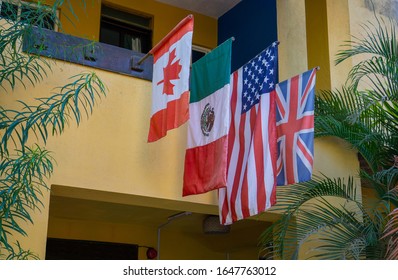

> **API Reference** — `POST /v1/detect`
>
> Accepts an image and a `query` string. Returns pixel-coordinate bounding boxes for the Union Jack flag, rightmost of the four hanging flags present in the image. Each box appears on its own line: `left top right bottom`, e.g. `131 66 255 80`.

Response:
275 68 316 186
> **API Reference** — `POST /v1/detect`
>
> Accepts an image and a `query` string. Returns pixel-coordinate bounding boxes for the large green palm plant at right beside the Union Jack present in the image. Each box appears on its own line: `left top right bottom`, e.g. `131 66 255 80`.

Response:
261 16 398 259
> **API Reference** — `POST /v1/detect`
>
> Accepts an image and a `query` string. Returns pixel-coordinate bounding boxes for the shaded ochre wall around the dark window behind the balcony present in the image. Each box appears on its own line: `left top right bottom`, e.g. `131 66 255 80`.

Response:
57 0 217 48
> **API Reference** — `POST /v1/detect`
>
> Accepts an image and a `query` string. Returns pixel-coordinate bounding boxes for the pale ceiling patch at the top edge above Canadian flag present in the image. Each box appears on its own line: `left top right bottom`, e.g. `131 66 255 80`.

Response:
156 0 241 18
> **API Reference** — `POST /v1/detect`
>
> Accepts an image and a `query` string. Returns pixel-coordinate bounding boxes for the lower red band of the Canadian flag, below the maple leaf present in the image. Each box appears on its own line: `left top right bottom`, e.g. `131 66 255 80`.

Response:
148 91 189 142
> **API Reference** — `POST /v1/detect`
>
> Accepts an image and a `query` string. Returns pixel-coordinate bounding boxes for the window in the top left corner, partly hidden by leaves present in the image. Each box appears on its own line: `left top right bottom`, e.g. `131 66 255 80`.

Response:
0 0 58 30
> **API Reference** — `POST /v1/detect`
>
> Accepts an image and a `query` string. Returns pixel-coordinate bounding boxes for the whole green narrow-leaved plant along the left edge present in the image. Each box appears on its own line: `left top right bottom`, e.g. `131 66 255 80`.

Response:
0 0 106 259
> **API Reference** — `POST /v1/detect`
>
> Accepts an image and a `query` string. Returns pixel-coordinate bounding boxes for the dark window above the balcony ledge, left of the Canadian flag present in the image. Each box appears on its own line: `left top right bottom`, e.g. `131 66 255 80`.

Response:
100 5 152 53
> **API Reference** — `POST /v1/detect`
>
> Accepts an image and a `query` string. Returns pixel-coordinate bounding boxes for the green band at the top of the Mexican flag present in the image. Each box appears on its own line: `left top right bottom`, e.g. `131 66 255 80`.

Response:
189 39 232 103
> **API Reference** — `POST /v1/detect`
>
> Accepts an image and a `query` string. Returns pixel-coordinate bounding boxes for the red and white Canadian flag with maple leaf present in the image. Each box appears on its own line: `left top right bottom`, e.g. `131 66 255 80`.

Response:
148 15 193 142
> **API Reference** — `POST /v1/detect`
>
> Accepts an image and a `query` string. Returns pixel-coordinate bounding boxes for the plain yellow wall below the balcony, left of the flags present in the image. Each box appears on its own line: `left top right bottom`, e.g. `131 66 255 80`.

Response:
41 65 214 206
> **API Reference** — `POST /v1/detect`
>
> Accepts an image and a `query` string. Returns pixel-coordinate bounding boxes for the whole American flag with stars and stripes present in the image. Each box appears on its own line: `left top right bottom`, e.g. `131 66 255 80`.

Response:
219 43 278 224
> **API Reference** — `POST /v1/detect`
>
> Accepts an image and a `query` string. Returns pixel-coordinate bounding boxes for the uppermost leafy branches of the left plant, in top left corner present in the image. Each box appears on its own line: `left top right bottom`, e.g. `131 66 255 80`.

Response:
0 0 86 90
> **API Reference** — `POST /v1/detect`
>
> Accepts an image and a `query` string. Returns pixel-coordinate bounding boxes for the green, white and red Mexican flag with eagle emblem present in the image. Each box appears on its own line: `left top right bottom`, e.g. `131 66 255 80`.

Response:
183 39 232 196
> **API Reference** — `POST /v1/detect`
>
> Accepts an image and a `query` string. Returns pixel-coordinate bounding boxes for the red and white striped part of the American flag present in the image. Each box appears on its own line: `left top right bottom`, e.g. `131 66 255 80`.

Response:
219 68 277 224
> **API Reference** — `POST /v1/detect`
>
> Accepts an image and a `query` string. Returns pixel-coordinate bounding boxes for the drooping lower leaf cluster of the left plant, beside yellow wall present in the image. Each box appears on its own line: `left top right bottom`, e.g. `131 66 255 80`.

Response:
0 146 54 250
